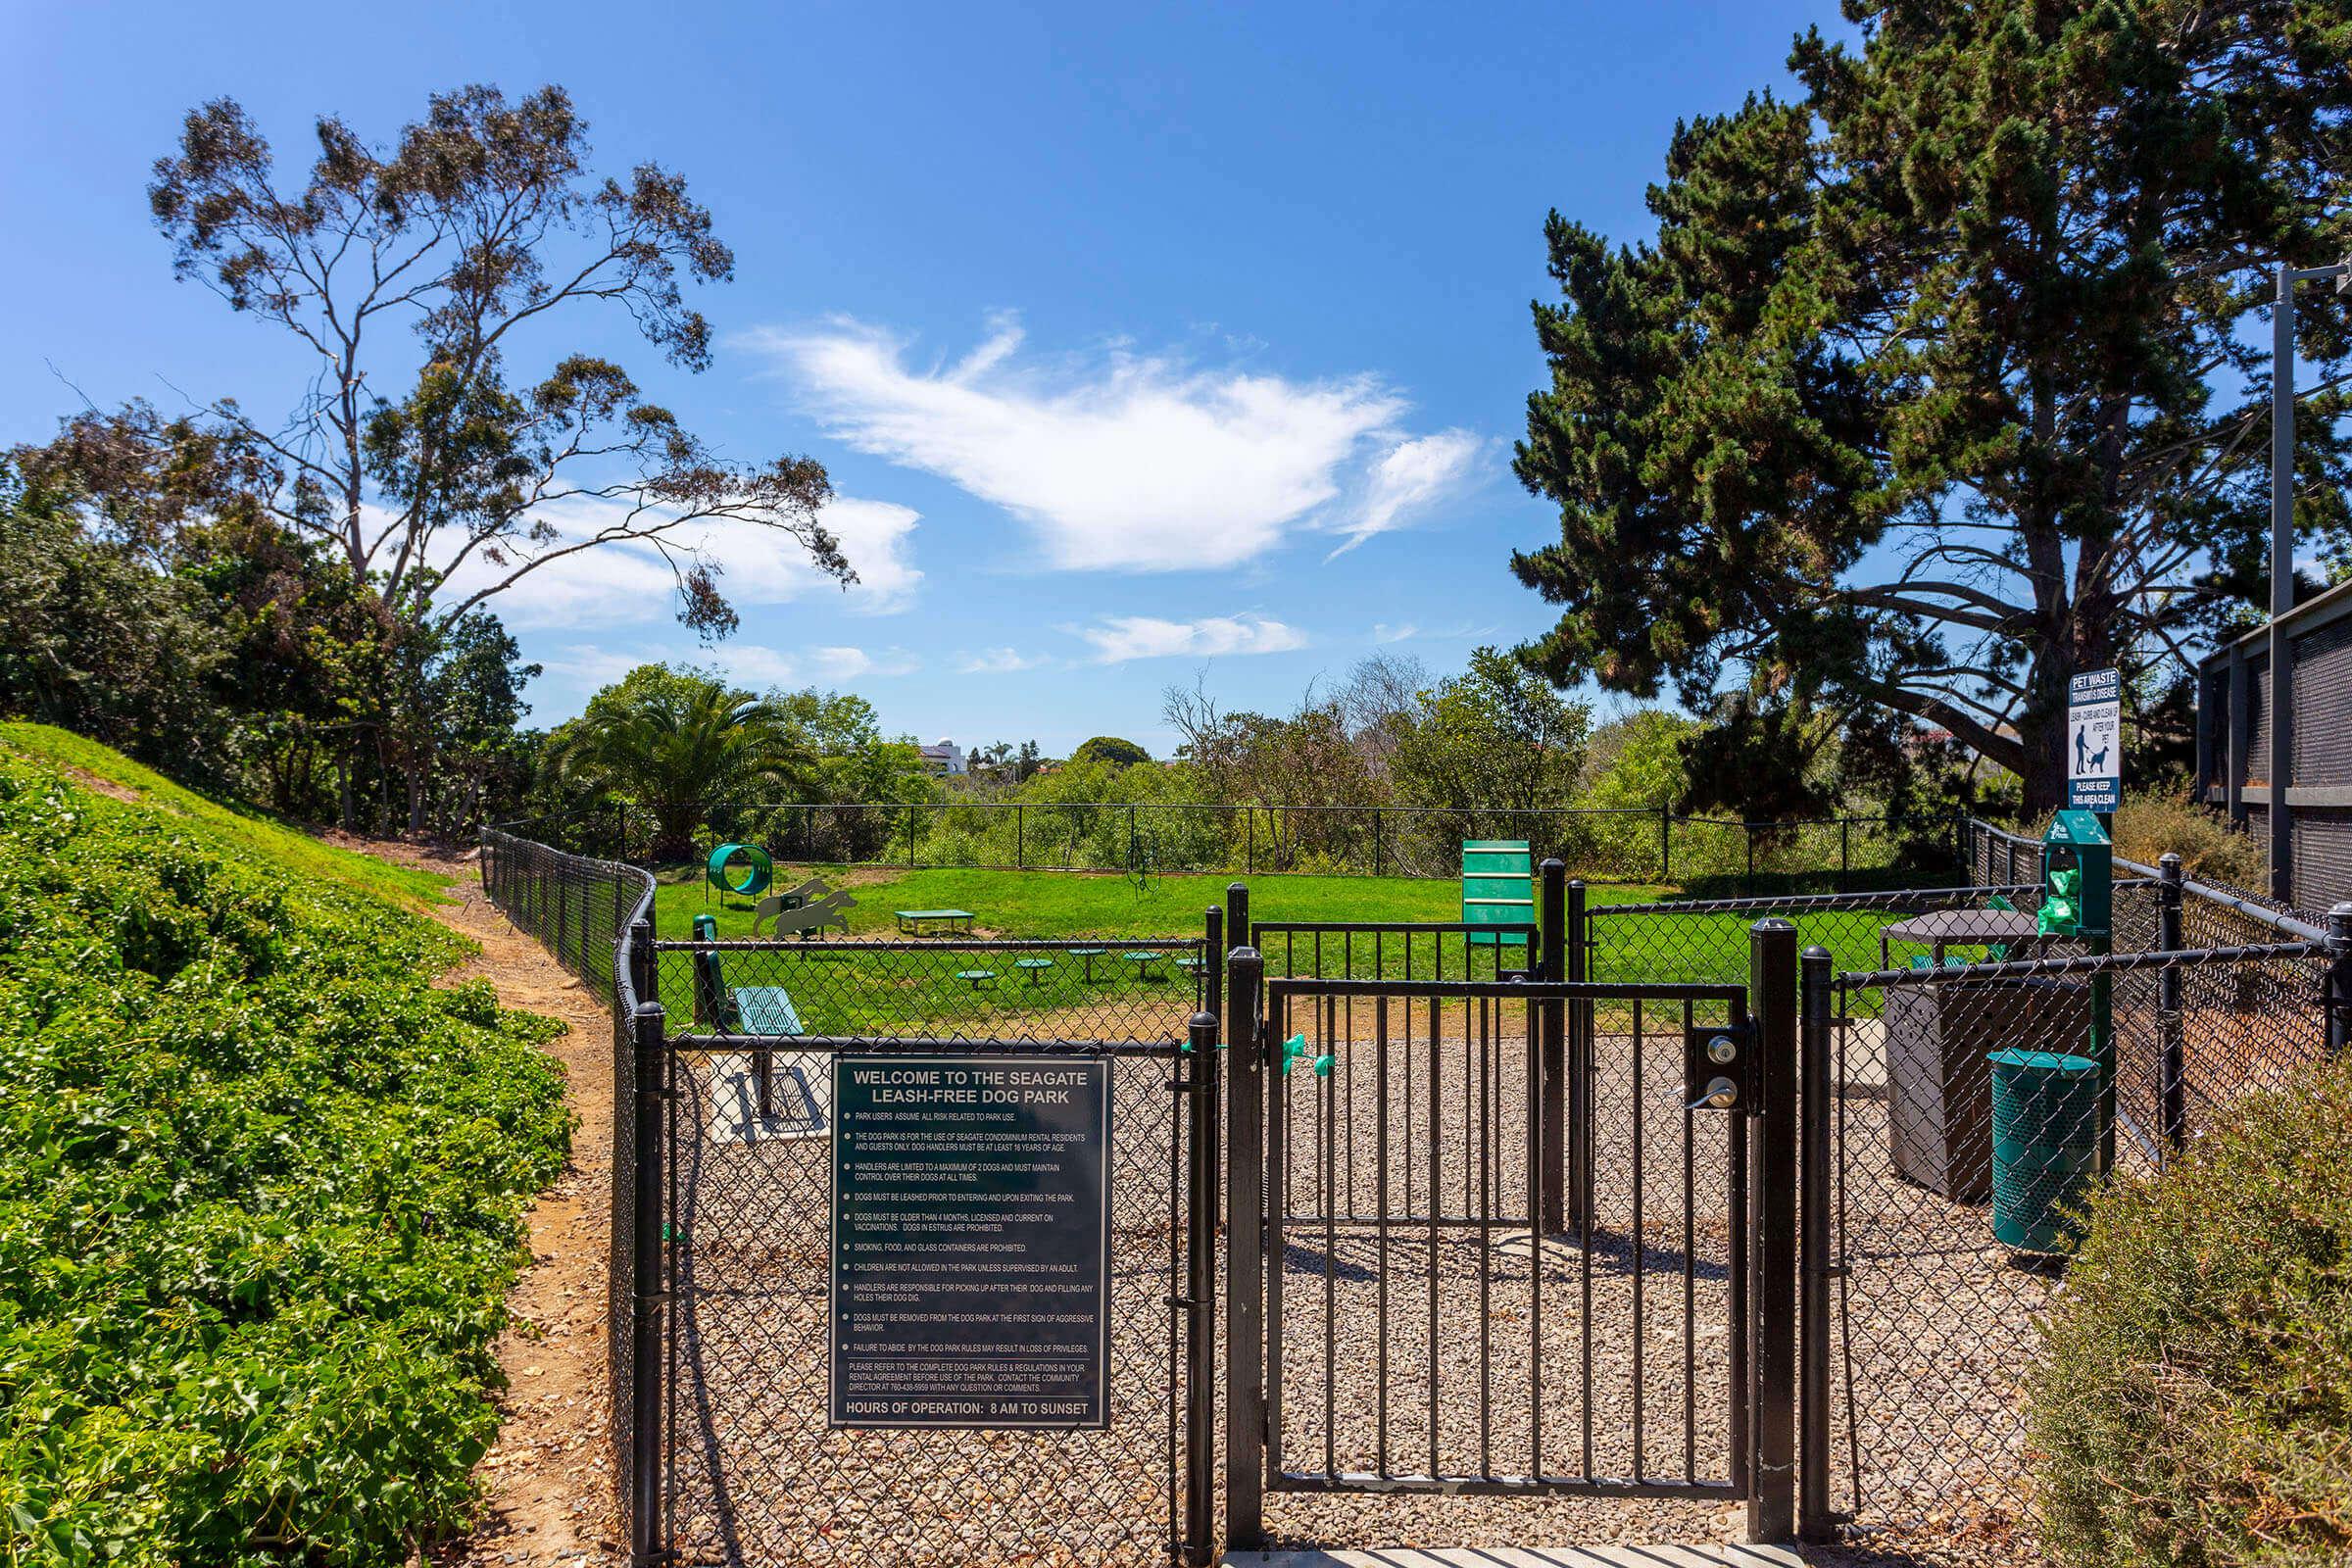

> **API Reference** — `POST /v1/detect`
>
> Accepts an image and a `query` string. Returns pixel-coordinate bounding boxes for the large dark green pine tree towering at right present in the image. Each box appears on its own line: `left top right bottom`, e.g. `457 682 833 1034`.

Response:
1512 0 2352 811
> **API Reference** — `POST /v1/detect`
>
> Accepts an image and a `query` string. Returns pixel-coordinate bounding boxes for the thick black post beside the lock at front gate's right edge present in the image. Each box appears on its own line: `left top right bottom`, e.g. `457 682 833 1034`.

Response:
1745 919 1797 1543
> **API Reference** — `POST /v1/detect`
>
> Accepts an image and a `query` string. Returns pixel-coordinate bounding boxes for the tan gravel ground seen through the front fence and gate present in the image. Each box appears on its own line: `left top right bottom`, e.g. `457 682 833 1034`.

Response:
654 1004 2051 1563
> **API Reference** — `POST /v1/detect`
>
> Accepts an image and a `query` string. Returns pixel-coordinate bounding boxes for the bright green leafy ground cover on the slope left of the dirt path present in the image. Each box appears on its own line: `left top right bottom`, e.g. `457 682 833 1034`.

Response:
0 753 569 1566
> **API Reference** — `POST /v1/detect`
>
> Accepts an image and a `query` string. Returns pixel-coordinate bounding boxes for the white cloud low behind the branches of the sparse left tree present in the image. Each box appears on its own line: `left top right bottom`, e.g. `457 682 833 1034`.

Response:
445 496 922 632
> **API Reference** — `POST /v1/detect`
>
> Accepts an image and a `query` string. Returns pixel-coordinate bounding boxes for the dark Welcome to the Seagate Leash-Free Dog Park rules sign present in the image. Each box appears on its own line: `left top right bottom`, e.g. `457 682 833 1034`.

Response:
825 1055 1110 1427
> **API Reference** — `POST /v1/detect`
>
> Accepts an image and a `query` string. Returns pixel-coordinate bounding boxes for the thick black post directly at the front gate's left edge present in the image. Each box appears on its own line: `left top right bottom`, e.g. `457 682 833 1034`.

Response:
1225 945 1265 1551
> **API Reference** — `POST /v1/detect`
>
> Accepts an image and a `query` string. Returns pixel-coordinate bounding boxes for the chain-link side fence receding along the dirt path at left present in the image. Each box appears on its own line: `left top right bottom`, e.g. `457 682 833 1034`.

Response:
480 827 654 1551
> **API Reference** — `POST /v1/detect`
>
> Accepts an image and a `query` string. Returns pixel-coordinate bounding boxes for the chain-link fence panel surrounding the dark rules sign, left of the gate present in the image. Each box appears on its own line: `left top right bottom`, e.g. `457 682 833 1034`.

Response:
659 938 1204 1563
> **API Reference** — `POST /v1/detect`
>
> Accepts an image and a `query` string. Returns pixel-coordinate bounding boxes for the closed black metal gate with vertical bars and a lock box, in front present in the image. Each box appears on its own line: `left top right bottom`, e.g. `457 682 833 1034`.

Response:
1225 921 1797 1546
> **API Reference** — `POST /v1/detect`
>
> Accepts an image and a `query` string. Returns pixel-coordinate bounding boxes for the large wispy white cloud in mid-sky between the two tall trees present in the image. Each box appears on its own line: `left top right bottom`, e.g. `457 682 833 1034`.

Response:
741 315 1480 571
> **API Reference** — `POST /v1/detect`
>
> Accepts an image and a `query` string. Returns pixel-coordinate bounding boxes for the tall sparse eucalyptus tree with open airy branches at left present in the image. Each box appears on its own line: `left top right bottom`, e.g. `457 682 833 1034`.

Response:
133 87 854 813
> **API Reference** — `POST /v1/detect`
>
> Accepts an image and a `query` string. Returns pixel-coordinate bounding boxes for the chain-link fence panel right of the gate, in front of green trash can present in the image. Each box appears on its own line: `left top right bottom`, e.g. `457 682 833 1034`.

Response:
1835 930 2324 1554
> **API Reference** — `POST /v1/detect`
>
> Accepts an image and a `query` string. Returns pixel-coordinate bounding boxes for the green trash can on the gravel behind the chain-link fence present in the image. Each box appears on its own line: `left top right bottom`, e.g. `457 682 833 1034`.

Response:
1985 1049 2098 1253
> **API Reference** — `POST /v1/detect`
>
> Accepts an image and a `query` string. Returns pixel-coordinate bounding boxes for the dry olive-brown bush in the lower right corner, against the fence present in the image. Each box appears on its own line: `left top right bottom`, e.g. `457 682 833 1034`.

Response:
2028 1062 2352 1568
